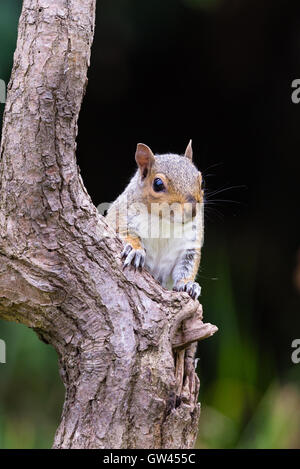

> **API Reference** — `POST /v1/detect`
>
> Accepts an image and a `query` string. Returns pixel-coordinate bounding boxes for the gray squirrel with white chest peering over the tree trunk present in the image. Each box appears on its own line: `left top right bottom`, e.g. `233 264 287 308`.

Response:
106 140 204 300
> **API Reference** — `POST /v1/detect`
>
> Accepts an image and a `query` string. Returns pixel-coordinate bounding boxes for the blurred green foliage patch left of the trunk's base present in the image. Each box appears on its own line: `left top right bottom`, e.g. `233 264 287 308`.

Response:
0 321 64 448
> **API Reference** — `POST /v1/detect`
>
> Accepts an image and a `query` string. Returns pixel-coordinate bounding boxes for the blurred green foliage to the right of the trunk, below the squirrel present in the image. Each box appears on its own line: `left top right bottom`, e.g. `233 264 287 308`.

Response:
197 234 300 448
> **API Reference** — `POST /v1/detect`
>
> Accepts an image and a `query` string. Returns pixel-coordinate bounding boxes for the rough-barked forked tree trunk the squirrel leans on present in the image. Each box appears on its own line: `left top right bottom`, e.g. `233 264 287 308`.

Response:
0 0 216 448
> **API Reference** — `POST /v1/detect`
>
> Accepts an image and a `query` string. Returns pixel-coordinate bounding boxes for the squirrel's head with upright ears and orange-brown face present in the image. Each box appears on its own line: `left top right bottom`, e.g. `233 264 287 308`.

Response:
135 140 203 219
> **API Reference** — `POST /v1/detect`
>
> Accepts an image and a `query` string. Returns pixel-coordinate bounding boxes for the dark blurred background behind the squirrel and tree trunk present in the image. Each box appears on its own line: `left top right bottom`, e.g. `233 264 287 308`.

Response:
0 0 300 447
